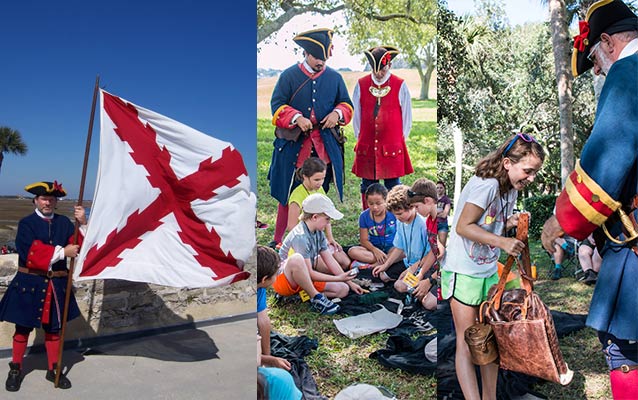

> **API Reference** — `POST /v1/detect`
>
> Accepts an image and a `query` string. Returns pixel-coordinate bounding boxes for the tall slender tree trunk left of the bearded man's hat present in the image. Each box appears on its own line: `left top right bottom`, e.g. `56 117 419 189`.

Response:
549 0 574 185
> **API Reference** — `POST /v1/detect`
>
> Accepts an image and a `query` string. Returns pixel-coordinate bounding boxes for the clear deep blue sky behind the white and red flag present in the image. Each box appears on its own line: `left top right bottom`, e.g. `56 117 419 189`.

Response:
0 0 256 199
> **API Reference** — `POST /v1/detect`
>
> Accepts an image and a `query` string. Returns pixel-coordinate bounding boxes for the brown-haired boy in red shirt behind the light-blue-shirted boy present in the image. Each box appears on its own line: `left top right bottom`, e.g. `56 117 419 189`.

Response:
408 178 444 310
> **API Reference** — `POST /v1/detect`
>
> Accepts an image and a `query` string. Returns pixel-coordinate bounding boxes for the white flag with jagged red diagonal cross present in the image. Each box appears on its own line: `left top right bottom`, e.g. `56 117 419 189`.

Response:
74 90 256 287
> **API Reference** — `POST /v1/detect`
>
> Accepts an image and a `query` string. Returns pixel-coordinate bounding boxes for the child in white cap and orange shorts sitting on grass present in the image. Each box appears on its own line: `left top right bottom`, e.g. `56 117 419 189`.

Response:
273 193 363 314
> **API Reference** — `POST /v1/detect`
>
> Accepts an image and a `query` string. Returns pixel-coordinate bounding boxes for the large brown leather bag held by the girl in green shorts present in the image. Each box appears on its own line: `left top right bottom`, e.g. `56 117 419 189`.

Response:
479 214 574 385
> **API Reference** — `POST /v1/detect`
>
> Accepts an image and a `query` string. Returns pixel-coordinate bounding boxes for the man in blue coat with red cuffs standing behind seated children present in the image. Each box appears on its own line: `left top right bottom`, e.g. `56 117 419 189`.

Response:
268 29 352 245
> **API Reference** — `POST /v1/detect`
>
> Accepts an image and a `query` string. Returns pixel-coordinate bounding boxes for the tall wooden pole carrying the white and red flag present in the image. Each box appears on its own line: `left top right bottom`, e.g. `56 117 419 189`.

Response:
54 75 100 388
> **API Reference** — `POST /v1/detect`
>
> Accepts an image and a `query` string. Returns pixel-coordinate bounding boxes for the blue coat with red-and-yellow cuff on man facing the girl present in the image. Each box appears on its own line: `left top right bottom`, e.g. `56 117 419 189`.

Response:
556 54 638 340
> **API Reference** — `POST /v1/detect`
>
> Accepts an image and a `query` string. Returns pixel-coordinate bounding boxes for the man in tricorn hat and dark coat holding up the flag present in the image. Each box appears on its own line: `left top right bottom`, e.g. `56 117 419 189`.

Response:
0 181 86 392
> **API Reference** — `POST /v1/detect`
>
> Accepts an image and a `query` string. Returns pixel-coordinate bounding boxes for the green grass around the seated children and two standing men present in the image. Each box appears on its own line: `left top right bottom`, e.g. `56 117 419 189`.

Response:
257 101 436 399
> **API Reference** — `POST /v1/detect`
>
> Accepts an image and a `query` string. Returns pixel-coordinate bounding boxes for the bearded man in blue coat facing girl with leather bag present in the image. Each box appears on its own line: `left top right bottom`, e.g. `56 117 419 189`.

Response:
542 0 638 399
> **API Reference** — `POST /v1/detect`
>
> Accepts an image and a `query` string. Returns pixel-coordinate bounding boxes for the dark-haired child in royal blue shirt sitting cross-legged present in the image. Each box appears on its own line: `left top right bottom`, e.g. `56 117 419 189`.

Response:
348 183 397 265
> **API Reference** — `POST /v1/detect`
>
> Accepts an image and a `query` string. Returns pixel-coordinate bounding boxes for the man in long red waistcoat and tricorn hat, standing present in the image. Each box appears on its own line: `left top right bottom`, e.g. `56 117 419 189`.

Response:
352 46 414 210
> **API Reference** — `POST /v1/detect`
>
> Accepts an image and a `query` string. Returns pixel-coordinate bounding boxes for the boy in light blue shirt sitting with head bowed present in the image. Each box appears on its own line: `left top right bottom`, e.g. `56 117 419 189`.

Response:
372 185 434 292
